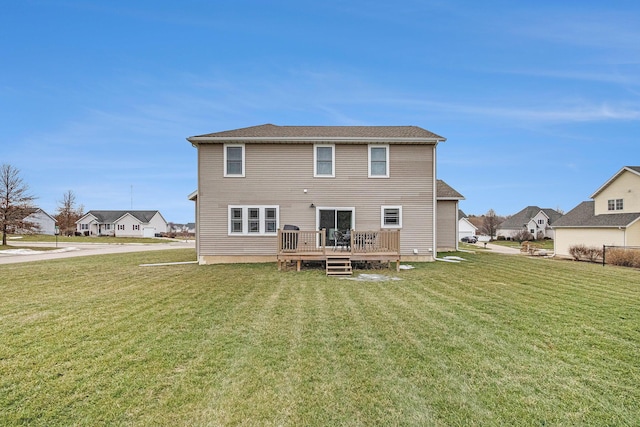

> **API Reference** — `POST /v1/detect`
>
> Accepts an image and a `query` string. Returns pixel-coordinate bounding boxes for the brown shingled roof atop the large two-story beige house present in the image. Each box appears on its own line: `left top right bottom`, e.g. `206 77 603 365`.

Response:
187 124 446 144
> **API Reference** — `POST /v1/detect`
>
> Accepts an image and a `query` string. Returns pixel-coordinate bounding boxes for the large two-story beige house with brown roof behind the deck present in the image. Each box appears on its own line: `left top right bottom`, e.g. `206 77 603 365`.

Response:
187 124 452 264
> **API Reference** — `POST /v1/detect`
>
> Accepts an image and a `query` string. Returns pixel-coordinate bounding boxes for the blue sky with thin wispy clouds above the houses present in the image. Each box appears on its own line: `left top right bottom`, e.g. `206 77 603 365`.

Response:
0 0 640 223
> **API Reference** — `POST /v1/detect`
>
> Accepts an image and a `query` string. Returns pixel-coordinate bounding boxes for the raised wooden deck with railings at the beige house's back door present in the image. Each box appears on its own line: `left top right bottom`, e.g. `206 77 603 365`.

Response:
278 230 400 271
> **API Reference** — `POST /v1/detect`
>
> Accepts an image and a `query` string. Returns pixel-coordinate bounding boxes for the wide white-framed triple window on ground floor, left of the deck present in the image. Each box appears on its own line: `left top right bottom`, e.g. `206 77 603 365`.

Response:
229 206 279 236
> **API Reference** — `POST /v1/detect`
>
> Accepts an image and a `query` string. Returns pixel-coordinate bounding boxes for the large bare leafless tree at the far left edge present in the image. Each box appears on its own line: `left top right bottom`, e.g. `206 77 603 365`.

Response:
0 164 37 246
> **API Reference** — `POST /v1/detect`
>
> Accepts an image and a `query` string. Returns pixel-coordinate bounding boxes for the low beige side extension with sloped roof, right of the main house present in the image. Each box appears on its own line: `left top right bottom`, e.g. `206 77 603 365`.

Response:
436 179 464 252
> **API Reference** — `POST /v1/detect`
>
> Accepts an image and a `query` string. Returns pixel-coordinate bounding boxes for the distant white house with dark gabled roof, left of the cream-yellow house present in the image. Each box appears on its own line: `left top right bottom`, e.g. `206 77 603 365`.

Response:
496 206 562 239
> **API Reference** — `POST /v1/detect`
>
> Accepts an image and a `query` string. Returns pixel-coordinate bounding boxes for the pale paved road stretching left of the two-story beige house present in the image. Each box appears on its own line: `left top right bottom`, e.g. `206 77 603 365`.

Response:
0 240 195 264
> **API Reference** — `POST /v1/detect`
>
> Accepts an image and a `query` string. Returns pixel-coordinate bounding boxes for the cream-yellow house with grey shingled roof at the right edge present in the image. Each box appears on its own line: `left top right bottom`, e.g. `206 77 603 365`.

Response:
553 166 640 257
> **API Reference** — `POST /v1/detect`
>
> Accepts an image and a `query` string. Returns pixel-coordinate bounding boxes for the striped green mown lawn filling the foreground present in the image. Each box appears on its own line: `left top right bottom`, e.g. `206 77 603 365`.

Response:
0 250 640 426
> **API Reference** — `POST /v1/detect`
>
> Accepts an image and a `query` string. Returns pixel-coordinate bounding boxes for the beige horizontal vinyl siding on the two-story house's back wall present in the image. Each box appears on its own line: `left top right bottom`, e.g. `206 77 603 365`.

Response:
197 142 435 257
